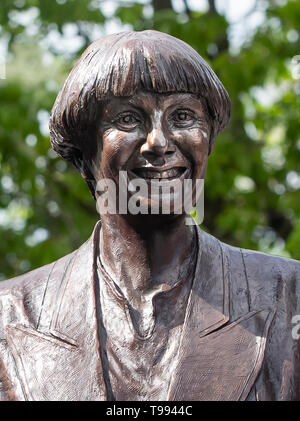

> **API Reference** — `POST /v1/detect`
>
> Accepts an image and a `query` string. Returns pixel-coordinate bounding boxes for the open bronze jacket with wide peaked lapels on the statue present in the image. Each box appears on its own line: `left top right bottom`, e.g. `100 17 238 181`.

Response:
0 222 300 401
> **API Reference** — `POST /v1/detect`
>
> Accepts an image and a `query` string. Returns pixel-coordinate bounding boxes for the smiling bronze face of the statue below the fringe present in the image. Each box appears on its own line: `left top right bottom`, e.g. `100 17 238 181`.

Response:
95 92 210 213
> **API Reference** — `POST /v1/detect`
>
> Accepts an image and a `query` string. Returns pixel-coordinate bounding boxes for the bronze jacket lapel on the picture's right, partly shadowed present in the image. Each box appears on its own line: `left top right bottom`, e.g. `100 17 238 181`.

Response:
169 226 273 401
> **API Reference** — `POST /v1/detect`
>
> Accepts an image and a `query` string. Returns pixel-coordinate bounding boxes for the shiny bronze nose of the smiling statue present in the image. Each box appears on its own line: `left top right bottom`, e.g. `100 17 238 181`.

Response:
141 127 174 165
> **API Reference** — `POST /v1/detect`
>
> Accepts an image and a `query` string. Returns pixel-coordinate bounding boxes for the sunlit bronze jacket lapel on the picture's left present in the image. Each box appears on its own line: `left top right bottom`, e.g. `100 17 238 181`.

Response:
7 221 106 400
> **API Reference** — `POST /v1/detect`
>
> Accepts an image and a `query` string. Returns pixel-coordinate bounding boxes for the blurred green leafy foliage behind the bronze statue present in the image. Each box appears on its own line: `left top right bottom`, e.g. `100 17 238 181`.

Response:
0 0 300 279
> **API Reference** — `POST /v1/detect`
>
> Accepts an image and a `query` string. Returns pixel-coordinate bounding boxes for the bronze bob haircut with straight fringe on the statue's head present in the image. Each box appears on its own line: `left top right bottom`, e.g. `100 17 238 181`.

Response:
50 30 230 194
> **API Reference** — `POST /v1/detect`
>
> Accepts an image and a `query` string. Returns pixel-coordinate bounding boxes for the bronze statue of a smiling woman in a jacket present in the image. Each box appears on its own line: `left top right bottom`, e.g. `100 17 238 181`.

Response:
0 31 300 401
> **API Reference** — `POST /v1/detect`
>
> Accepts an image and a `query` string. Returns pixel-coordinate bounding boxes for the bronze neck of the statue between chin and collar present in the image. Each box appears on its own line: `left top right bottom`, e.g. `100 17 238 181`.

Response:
100 215 194 302
